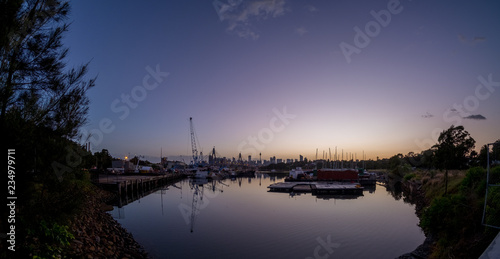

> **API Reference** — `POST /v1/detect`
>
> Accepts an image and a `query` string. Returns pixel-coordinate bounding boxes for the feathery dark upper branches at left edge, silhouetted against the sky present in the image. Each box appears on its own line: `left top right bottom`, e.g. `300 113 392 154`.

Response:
0 0 95 138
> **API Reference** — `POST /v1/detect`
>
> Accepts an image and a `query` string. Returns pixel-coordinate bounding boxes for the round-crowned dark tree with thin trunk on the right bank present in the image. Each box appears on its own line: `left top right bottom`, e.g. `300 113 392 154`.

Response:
434 125 476 194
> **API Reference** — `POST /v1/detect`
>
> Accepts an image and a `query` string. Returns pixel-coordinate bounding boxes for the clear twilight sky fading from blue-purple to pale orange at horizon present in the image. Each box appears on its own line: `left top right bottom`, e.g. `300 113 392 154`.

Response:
64 0 500 162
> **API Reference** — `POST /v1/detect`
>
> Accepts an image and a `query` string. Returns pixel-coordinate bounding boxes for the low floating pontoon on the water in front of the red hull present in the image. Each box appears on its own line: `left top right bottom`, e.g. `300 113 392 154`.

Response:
267 182 364 195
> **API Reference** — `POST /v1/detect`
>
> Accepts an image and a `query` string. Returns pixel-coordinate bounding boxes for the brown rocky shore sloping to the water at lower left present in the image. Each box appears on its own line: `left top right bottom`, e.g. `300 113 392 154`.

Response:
63 188 148 259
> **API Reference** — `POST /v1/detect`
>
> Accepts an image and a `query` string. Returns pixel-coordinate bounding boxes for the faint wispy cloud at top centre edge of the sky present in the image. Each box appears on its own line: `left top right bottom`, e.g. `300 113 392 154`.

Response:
214 0 286 40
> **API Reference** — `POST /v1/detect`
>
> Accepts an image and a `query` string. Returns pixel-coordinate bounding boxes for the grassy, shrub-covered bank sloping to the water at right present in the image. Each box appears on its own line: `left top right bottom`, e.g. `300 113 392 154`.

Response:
392 168 500 259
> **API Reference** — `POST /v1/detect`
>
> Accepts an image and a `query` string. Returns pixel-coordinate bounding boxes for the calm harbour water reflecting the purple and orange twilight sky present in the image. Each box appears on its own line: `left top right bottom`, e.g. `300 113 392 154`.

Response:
111 175 425 258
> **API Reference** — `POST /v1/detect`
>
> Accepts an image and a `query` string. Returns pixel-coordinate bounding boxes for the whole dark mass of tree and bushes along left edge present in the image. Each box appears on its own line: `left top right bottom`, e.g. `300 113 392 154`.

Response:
0 0 95 258
